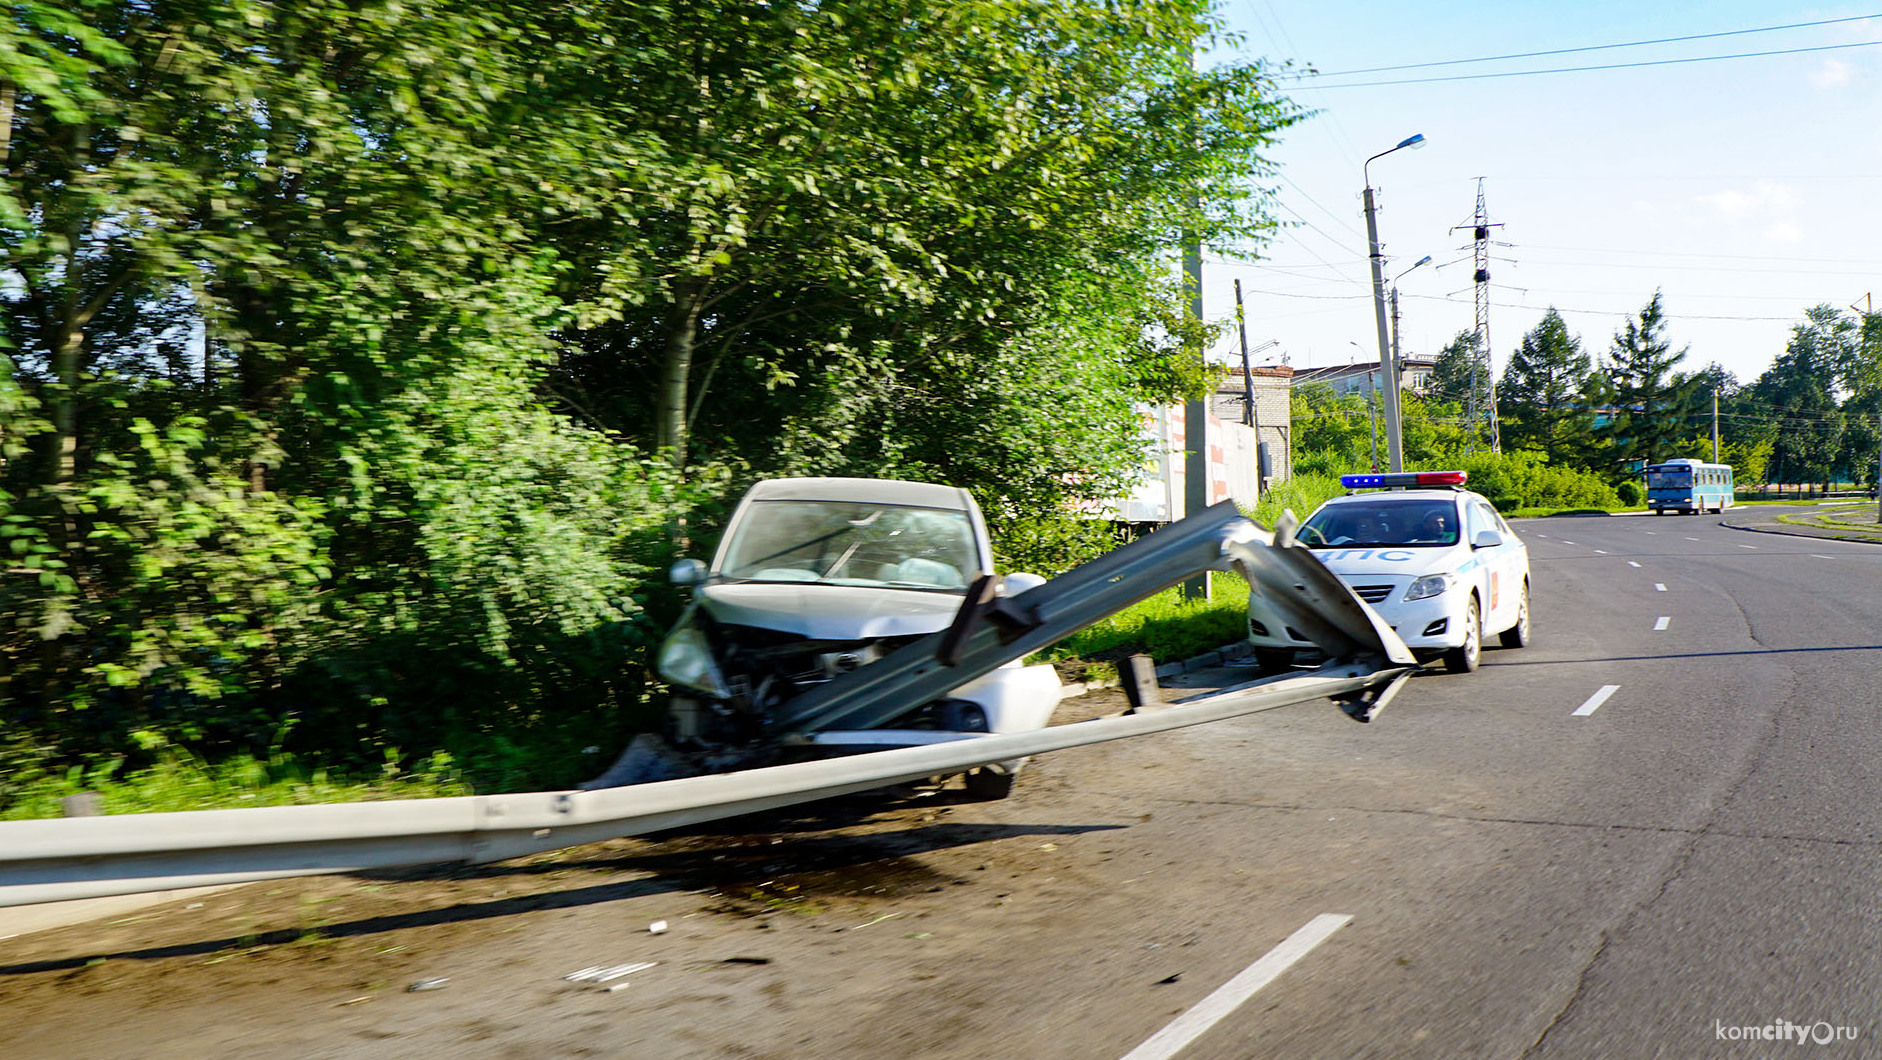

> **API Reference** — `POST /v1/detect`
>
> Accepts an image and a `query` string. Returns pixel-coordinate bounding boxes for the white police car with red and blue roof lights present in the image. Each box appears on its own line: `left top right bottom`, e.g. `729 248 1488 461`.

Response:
1248 471 1530 674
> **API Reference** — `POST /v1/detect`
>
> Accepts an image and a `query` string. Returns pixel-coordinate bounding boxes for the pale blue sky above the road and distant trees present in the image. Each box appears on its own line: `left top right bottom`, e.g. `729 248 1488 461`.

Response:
1204 0 1882 382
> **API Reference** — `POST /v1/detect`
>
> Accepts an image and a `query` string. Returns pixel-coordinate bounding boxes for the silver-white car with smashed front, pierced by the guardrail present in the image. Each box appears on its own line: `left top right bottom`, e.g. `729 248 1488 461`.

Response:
659 478 1060 798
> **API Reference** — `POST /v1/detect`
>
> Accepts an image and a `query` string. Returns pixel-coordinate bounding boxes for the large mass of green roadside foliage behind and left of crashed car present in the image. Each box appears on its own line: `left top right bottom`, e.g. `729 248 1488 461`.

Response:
0 0 1297 783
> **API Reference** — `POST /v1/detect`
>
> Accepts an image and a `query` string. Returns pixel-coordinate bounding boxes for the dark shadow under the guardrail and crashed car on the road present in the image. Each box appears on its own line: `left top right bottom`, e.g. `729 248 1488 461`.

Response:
0 808 1124 979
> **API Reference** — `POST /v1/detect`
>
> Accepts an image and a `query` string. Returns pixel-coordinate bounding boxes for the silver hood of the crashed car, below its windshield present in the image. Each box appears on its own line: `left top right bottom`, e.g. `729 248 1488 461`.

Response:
698 582 962 640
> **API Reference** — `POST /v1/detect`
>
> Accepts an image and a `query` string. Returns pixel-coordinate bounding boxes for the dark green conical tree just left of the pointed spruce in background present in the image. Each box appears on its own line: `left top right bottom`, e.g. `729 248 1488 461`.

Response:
1496 307 1594 463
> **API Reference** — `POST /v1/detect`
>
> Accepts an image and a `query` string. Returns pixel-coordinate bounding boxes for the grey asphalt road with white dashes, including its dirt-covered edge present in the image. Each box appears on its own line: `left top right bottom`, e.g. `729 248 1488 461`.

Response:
0 516 1882 1060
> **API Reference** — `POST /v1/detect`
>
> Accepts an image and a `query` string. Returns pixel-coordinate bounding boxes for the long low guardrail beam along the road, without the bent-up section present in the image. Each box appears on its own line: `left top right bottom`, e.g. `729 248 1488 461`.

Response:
0 663 1412 906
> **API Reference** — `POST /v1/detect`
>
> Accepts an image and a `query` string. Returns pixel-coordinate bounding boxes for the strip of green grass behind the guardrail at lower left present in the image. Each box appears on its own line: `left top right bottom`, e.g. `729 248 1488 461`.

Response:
0 751 471 821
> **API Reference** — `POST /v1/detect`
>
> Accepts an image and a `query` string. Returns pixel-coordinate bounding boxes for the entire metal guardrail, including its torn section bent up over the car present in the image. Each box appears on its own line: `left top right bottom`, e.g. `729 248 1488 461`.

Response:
0 505 1417 906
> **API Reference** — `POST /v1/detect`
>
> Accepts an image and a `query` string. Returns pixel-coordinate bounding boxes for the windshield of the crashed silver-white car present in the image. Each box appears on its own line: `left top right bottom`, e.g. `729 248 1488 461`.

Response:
717 501 981 593
